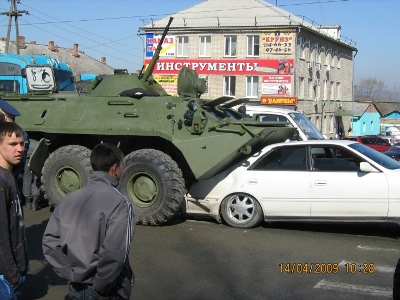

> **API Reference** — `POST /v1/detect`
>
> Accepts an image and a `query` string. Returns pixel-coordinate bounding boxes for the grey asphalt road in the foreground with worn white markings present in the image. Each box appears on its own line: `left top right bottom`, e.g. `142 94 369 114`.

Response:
23 203 400 300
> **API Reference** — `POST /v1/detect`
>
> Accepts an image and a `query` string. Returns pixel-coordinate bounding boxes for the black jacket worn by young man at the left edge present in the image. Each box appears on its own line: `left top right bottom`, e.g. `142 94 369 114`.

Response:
0 167 29 285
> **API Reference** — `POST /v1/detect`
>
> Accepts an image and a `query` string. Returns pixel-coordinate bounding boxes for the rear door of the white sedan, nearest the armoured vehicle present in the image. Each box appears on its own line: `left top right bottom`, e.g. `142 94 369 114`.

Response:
244 145 311 218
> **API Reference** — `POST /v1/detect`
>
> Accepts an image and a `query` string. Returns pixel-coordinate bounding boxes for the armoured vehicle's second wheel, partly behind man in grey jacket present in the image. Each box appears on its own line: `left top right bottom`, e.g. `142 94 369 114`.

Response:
42 145 93 207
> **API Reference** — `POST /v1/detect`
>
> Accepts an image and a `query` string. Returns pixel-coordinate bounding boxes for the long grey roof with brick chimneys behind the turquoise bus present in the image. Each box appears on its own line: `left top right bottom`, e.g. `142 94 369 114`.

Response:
0 40 114 75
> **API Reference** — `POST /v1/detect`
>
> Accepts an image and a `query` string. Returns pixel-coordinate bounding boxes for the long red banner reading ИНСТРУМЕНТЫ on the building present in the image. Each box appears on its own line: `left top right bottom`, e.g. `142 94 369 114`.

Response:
145 59 294 75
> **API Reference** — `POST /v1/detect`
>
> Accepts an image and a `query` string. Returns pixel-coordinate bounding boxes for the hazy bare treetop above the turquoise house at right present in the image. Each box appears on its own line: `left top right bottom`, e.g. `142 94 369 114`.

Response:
354 78 386 101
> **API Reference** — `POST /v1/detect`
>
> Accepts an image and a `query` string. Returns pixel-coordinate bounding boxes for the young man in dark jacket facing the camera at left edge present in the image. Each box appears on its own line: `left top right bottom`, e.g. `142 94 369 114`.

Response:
0 122 29 300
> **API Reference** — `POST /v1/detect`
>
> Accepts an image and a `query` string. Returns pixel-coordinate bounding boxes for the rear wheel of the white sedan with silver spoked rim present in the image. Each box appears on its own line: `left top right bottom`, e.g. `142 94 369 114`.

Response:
221 193 263 228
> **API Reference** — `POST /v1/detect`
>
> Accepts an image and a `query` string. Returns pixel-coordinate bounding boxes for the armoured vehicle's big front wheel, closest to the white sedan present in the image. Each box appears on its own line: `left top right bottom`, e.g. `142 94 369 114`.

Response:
118 149 184 225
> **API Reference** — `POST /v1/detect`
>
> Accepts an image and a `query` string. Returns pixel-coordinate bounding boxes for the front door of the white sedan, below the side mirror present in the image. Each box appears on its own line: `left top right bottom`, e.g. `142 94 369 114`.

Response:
310 146 388 218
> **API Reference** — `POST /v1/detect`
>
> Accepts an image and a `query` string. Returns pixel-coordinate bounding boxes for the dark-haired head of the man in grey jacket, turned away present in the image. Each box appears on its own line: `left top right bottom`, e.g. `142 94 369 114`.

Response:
90 143 124 179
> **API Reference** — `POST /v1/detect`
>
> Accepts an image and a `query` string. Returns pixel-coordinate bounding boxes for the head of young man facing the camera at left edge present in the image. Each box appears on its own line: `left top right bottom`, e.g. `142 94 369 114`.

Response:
0 122 25 169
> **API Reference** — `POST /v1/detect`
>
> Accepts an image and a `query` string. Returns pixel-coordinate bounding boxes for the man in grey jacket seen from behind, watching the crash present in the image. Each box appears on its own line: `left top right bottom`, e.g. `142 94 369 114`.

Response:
42 144 135 300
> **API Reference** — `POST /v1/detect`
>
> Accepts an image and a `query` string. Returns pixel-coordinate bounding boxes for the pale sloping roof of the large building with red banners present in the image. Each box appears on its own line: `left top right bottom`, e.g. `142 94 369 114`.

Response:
140 0 356 50
